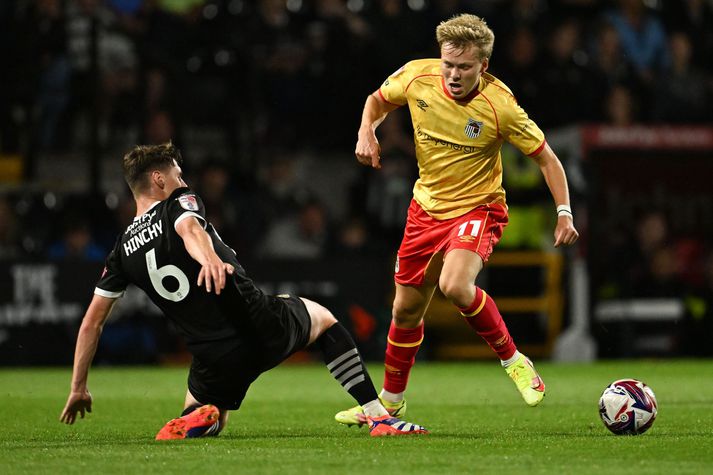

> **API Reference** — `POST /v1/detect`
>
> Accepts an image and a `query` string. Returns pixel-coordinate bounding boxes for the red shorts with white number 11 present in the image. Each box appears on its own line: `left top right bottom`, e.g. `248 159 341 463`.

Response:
394 200 508 285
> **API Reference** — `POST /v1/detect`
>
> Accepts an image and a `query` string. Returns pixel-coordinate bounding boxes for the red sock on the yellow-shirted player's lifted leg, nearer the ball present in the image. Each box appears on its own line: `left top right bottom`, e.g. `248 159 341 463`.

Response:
459 286 517 360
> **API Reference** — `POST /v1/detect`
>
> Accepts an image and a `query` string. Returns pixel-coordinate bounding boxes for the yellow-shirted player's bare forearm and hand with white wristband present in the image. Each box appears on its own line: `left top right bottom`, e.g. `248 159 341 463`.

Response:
534 143 579 247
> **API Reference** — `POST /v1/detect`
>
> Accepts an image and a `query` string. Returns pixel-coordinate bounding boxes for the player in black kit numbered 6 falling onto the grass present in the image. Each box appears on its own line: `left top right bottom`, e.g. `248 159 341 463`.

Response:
60 143 427 439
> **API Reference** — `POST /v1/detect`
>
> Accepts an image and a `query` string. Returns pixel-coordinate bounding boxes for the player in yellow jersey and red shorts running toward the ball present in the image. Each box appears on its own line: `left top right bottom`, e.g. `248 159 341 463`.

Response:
336 14 579 425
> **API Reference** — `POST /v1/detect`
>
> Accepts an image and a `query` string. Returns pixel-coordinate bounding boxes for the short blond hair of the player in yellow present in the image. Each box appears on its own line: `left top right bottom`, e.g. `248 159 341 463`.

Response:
436 13 495 60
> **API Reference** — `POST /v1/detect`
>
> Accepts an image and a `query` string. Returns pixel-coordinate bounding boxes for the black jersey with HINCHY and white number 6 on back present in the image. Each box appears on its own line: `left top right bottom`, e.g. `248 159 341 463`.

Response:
94 188 267 355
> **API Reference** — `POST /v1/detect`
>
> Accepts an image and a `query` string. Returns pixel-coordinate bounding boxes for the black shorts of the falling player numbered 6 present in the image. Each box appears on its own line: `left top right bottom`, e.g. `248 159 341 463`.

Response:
188 296 312 409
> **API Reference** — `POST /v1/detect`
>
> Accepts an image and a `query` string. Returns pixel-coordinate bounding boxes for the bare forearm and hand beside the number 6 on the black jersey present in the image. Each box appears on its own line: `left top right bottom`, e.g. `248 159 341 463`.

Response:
176 217 234 295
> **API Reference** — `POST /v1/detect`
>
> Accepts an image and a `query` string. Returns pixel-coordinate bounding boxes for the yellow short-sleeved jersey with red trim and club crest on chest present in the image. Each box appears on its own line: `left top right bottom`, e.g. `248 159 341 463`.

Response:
379 59 545 219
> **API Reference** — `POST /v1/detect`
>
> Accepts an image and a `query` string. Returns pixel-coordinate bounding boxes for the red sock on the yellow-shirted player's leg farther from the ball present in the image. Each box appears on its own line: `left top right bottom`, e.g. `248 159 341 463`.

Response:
384 320 423 393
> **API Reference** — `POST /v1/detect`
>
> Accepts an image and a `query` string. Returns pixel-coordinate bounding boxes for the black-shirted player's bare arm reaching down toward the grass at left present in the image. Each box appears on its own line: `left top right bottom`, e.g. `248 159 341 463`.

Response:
59 295 116 424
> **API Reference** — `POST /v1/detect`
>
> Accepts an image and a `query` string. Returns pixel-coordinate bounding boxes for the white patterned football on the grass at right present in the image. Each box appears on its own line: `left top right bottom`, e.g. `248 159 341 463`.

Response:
599 379 658 435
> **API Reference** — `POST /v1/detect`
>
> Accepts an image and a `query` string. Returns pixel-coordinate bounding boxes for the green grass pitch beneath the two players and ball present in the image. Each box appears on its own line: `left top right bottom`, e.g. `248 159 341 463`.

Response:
0 360 713 475
